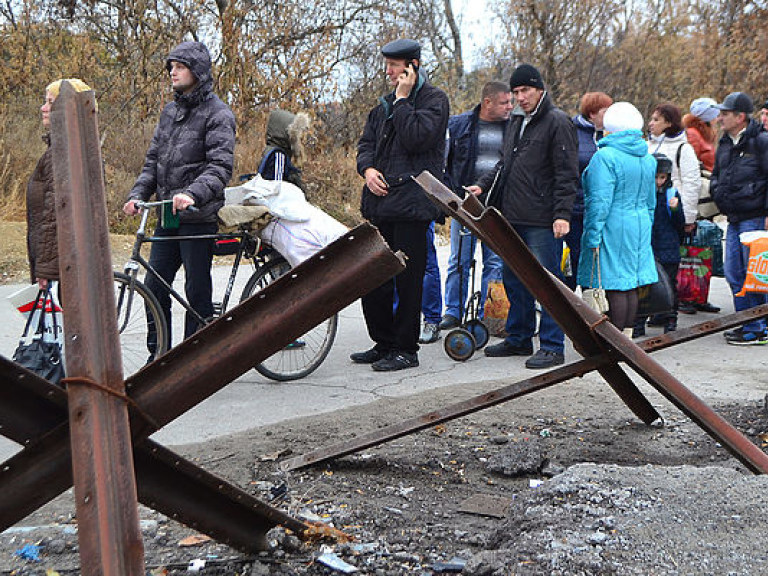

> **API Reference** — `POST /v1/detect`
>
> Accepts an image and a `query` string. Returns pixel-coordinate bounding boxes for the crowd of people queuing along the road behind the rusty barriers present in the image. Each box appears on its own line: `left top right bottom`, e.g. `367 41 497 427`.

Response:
27 39 768 371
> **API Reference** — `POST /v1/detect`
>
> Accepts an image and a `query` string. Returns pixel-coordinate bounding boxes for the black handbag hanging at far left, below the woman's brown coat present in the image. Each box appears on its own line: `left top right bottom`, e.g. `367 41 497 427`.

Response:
13 288 64 384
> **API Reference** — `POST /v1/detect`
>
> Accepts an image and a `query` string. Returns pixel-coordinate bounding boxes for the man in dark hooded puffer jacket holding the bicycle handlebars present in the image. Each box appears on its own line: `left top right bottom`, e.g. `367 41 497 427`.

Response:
123 42 235 360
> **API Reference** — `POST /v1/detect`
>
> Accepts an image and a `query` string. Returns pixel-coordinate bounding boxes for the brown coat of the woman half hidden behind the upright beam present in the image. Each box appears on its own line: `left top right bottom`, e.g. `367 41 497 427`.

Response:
27 134 59 282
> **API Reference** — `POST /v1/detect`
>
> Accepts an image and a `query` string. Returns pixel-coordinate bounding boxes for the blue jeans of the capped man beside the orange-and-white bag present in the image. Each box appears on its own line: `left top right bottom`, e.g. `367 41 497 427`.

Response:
724 216 768 332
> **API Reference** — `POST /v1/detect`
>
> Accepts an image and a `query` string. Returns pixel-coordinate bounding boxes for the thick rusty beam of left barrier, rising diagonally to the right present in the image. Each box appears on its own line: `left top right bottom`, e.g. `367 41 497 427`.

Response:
0 224 404 540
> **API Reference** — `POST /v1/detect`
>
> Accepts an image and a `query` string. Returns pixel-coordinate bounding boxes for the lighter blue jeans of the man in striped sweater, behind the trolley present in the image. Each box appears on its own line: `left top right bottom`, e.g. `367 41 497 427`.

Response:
445 220 504 320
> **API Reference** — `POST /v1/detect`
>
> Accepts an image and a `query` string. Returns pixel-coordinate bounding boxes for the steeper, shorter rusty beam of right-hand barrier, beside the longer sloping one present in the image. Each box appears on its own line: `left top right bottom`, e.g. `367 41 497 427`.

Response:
415 171 661 424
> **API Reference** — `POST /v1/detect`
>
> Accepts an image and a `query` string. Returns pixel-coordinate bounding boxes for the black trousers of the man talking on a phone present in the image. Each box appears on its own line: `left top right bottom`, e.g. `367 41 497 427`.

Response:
362 221 429 353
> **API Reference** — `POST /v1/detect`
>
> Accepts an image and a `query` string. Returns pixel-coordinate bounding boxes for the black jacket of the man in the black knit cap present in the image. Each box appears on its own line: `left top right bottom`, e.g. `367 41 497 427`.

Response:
478 93 579 228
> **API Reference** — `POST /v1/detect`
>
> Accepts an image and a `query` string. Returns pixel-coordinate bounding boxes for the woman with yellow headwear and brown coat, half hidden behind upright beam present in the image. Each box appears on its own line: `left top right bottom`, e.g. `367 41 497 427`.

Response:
27 78 91 290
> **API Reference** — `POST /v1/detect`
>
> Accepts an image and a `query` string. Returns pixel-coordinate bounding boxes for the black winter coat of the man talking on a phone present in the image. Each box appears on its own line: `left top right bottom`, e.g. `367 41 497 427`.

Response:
357 75 449 224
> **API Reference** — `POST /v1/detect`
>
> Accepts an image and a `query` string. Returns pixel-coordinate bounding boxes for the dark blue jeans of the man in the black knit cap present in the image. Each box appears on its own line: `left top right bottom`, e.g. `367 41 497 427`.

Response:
502 226 565 354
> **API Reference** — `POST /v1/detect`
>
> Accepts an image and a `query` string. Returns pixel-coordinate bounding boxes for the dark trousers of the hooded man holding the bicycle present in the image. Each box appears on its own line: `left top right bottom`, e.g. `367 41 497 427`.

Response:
146 222 218 353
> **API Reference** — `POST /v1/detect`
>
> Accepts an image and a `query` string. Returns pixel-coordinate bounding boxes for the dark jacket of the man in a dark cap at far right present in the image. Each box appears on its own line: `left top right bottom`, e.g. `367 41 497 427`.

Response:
710 120 768 222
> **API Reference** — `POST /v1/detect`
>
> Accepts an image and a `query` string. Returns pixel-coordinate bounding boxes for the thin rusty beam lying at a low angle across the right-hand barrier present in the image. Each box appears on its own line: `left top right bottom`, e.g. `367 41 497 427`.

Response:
279 305 768 471
